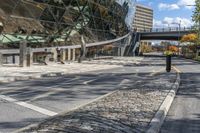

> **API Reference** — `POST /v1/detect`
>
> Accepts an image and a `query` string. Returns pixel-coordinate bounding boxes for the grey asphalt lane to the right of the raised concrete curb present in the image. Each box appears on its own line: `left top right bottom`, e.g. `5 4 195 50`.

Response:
160 59 200 133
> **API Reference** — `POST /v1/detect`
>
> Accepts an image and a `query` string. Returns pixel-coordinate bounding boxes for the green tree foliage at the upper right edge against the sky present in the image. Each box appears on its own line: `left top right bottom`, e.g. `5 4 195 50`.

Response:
193 0 200 45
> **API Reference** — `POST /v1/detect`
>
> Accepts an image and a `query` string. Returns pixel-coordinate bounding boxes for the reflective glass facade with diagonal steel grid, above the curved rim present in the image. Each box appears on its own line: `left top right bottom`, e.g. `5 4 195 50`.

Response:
0 0 135 45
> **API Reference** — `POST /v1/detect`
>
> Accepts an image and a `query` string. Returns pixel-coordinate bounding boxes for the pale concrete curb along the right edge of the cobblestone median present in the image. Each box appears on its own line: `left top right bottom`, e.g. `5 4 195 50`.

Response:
146 68 181 133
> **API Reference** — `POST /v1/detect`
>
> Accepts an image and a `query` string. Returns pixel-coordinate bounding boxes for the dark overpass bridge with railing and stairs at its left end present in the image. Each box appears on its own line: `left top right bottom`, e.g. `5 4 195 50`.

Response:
124 27 195 56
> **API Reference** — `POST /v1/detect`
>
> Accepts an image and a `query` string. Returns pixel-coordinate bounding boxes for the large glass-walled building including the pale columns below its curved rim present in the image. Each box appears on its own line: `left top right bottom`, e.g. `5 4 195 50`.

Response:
0 0 136 62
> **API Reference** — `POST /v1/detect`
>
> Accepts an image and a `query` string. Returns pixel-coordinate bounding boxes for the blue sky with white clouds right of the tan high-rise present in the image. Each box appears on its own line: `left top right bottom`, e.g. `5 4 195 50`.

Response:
137 0 195 27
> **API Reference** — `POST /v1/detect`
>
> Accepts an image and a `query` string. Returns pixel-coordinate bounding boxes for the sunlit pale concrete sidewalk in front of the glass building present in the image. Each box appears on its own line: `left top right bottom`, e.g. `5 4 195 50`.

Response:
0 57 143 83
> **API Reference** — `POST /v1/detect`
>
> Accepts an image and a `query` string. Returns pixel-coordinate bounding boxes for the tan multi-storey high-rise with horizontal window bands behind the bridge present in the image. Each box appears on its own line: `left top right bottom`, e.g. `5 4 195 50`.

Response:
133 4 153 31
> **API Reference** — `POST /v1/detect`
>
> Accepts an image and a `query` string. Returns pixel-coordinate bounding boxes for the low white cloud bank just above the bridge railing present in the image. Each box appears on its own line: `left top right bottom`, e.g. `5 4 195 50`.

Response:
154 17 194 28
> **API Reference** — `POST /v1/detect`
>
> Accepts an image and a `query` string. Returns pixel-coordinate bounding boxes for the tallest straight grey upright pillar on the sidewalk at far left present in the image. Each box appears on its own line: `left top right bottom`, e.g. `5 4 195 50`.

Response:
19 40 27 67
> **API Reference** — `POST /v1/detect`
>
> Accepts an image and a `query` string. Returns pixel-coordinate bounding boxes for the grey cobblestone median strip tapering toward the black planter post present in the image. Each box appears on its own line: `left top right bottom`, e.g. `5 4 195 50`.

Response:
17 73 176 133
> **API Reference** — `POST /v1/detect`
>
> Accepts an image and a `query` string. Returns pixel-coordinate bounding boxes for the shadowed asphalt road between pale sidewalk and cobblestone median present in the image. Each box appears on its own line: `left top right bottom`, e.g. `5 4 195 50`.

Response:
0 58 165 132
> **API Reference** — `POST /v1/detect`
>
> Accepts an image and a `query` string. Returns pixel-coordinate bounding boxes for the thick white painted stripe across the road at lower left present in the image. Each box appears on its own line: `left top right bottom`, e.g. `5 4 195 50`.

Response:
0 95 58 116
